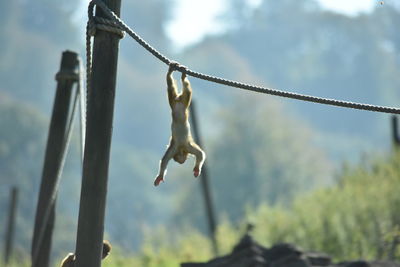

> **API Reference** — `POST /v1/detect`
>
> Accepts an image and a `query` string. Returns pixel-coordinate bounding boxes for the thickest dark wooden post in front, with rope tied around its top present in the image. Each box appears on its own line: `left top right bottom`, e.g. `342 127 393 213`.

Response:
75 0 121 267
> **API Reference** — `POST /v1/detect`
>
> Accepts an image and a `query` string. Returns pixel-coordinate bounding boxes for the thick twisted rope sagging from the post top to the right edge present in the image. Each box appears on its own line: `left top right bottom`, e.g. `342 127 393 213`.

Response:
86 0 400 114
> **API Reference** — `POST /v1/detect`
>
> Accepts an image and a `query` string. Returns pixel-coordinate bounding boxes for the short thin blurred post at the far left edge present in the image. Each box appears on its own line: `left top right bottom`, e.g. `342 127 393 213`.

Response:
4 186 18 265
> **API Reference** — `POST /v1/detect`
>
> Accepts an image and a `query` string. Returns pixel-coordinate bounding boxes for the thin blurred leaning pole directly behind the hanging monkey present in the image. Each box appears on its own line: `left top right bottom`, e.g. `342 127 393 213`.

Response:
190 100 218 255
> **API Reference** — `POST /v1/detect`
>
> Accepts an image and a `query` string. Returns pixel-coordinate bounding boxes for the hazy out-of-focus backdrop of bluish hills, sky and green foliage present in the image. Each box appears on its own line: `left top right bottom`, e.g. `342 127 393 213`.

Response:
0 0 400 266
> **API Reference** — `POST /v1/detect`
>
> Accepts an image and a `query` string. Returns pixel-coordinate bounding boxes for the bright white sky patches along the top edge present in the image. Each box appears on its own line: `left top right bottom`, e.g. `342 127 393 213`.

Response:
166 0 382 50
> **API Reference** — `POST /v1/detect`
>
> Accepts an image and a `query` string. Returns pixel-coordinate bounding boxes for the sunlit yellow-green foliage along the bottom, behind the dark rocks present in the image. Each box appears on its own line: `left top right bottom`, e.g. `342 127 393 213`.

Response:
105 153 400 267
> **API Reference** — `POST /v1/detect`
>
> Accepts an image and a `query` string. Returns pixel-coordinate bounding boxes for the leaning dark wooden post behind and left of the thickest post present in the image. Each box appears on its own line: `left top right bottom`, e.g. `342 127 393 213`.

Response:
31 51 79 267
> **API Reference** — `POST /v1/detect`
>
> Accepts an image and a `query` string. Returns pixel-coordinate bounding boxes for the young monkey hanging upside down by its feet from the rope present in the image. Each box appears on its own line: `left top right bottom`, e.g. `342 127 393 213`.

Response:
154 62 206 186
